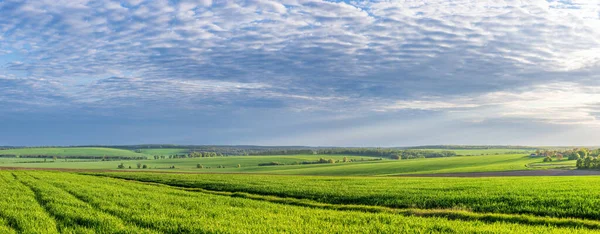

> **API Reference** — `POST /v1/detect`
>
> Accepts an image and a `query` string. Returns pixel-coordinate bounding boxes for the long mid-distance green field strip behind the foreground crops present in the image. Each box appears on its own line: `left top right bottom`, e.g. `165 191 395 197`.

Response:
0 154 544 176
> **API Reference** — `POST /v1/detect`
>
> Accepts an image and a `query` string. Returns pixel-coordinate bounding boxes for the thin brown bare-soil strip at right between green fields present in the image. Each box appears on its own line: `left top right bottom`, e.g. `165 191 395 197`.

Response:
395 169 600 177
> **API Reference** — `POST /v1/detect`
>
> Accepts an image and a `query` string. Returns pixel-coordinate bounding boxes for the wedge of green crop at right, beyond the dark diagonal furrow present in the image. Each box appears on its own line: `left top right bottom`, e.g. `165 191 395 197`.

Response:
101 173 600 220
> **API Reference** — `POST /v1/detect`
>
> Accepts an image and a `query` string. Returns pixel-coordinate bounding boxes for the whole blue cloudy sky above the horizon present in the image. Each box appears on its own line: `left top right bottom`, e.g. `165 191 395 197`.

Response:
0 0 600 147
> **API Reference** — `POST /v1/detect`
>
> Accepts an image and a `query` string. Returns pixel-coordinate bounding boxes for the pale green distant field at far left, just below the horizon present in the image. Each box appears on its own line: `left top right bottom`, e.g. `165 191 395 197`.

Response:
0 147 148 157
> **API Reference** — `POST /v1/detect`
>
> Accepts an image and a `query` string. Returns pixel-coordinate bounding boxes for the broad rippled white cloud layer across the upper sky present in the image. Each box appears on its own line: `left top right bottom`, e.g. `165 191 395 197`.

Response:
0 0 600 123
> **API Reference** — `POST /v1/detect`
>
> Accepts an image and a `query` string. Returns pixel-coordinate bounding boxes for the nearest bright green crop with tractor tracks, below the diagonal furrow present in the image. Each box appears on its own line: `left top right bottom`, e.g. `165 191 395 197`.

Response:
0 171 598 233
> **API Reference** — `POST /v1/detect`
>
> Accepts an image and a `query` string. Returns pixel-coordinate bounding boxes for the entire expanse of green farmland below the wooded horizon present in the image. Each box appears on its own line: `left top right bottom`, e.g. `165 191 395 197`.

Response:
0 148 600 233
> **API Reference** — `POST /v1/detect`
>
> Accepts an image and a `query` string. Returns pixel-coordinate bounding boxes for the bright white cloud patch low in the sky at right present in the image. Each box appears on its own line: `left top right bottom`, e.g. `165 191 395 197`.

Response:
382 83 600 125
